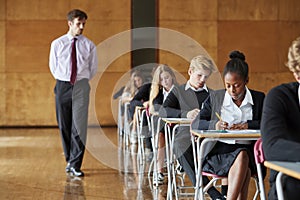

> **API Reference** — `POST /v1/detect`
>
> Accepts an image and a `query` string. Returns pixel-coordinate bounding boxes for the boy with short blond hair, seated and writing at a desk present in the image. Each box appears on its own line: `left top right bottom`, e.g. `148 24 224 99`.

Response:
159 55 226 199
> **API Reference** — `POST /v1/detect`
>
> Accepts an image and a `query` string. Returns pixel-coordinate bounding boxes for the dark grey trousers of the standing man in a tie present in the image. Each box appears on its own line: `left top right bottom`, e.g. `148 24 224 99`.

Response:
54 79 90 169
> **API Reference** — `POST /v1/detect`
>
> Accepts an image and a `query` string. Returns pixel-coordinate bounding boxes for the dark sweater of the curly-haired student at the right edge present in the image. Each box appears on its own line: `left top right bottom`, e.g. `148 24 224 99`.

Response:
261 85 300 162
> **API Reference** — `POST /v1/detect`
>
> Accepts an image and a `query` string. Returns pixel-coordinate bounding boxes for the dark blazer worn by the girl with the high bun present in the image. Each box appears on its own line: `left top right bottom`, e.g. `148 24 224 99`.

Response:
192 89 265 130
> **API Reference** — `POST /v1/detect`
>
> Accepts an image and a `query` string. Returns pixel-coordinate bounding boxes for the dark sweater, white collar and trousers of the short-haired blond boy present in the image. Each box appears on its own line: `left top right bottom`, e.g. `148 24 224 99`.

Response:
159 82 212 185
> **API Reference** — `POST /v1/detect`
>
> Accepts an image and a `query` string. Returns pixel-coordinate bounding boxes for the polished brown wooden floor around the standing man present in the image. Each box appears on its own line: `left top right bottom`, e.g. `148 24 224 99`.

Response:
0 127 266 200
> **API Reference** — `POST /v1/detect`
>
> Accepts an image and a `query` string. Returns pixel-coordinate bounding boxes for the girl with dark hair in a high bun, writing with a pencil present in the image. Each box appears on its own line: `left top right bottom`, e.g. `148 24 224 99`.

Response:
192 51 265 199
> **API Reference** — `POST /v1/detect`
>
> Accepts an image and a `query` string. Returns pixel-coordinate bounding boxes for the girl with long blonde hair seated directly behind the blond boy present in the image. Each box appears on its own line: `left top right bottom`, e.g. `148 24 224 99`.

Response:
144 64 177 184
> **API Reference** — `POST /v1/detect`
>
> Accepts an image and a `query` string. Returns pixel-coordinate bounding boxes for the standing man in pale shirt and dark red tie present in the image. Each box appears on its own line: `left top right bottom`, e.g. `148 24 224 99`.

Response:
49 9 98 177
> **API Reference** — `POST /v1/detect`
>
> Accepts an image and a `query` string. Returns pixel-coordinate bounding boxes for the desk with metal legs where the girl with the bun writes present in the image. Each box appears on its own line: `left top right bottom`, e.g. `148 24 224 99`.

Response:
191 130 260 200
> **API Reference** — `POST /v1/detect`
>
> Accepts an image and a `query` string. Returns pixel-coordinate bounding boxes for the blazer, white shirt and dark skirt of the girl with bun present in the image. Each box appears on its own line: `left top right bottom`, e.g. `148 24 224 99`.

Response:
192 87 265 176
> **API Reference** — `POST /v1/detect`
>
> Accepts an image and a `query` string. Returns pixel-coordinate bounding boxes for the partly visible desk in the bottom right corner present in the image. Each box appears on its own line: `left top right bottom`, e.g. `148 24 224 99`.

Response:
264 161 300 200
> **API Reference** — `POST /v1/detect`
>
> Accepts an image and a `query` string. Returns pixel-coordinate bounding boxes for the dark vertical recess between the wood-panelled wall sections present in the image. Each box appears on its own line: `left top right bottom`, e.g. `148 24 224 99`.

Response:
131 0 158 80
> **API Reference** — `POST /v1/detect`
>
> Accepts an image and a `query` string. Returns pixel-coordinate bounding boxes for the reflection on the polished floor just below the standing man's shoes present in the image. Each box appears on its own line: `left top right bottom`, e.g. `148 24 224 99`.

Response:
64 175 86 200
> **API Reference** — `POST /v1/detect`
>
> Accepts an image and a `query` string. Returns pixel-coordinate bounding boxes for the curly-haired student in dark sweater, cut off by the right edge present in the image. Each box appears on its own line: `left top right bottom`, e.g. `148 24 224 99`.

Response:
261 37 300 200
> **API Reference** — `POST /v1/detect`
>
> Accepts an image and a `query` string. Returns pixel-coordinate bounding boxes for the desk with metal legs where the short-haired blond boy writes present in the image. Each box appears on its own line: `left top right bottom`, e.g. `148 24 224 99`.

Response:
161 118 192 199
